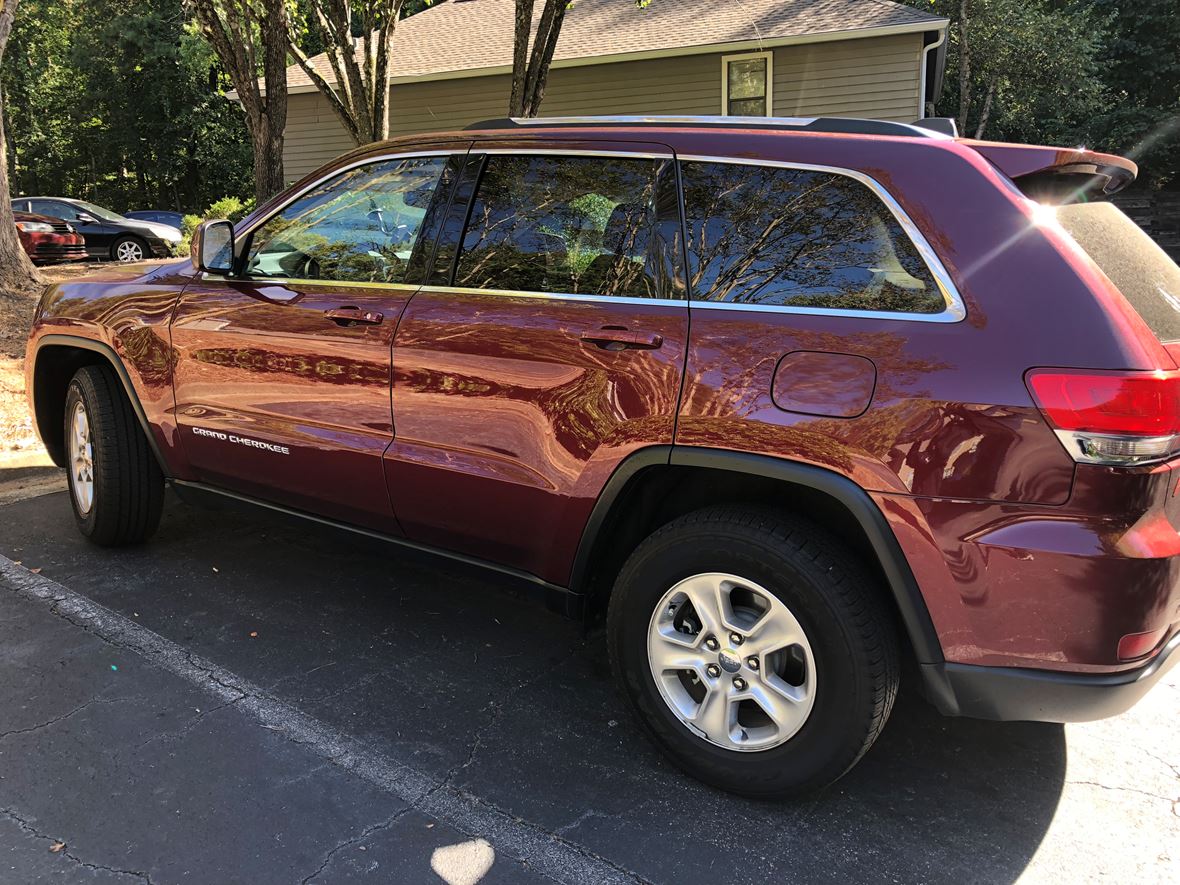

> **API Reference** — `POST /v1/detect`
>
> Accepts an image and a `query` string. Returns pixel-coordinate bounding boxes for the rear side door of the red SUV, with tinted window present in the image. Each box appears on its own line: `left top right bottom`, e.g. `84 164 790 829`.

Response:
386 143 688 583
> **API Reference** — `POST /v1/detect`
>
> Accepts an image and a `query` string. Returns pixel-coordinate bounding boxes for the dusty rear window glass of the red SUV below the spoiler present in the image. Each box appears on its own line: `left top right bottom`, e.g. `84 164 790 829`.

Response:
1056 203 1180 343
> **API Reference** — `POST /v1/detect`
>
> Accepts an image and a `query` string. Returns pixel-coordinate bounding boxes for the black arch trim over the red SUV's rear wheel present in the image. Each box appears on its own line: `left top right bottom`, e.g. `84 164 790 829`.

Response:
570 446 944 665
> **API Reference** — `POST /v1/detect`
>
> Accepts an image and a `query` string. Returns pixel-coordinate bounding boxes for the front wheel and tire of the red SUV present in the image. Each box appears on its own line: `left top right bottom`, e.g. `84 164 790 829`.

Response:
64 366 164 546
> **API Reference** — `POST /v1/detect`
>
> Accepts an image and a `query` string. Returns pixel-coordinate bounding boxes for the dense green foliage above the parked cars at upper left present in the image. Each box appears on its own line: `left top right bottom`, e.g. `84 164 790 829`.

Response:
4 0 251 211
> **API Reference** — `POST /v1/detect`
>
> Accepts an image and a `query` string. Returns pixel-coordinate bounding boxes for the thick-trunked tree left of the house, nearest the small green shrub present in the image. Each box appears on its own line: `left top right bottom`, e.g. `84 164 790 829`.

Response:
189 0 288 203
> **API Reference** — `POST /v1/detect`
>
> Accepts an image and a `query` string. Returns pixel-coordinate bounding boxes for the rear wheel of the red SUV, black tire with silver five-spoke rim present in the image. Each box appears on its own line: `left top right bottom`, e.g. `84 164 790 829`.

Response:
608 505 899 799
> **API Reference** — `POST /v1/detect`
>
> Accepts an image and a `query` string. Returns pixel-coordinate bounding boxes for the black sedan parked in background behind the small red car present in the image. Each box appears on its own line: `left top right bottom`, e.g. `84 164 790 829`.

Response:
12 197 181 261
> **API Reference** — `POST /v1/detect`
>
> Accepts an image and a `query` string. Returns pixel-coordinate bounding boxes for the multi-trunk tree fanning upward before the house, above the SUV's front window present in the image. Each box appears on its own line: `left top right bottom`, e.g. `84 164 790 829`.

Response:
287 0 406 145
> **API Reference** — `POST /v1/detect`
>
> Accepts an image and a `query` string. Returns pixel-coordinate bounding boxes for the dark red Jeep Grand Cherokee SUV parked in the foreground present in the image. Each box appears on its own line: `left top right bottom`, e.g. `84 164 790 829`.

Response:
20 118 1180 797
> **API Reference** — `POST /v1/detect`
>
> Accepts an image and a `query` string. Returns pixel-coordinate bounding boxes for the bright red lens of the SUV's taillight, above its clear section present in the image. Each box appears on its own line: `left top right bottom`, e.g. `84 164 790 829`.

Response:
1028 369 1180 437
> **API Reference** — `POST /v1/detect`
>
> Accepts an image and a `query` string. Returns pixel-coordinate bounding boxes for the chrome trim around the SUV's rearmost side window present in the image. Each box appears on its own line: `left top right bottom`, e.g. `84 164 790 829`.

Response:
677 153 966 323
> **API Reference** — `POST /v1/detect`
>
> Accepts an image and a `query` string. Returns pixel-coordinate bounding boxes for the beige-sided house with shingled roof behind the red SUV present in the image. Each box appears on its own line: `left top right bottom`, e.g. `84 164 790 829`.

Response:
283 0 948 178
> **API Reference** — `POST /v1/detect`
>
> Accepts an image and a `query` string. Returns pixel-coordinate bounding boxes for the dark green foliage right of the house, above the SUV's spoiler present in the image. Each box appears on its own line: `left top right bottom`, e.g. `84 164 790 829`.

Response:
902 0 1180 186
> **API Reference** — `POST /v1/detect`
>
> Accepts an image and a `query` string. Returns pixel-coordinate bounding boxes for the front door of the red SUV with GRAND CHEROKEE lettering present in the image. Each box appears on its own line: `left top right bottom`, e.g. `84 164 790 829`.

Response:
172 145 465 533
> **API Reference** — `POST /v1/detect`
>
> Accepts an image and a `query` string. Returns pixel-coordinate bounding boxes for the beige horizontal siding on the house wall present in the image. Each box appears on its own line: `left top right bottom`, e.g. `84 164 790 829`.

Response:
283 34 922 178
